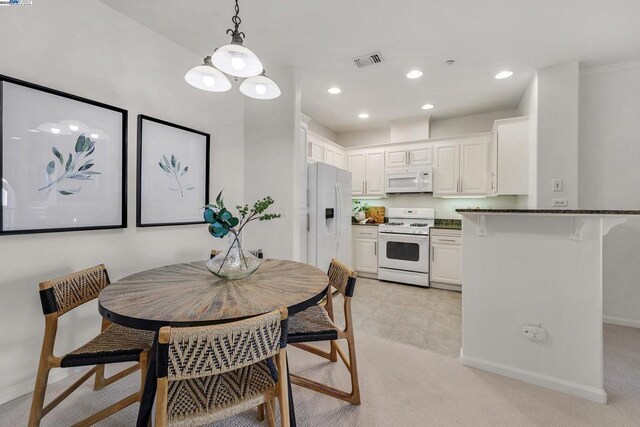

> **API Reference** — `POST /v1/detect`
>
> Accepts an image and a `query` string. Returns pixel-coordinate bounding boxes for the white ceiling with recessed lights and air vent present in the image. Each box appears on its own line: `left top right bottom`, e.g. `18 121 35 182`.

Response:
101 0 640 132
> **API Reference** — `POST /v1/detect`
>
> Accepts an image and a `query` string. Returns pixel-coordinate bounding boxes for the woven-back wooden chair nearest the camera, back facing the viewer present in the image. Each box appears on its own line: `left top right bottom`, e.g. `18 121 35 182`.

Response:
156 309 289 427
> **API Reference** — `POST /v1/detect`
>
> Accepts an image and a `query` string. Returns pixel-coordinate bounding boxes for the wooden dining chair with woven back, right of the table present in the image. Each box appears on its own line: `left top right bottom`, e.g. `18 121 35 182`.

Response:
287 258 360 405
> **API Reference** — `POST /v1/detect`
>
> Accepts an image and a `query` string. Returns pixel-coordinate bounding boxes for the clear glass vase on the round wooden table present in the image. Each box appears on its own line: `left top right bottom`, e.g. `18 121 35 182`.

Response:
207 235 262 280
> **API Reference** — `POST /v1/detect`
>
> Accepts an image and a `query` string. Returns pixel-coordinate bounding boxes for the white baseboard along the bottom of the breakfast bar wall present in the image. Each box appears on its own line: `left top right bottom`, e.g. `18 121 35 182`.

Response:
459 349 607 404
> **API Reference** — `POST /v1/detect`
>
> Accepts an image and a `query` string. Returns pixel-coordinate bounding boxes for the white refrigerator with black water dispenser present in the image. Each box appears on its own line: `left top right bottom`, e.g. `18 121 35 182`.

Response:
307 163 352 271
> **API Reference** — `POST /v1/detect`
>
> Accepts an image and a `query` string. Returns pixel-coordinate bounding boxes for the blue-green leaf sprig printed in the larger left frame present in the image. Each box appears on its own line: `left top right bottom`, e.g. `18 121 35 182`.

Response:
38 135 100 196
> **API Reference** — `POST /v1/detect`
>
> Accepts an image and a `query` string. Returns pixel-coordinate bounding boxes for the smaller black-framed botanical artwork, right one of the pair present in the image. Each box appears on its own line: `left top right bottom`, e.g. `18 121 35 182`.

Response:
136 115 210 227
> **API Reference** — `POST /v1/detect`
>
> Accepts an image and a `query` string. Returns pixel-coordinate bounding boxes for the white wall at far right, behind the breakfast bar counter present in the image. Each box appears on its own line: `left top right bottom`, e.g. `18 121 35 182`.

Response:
579 62 640 327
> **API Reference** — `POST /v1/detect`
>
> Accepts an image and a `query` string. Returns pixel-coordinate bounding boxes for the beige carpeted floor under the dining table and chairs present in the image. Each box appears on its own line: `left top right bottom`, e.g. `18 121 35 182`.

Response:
0 325 640 427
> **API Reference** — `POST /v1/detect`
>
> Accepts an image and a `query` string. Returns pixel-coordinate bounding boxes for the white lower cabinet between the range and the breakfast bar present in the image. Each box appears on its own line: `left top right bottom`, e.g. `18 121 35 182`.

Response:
429 229 462 291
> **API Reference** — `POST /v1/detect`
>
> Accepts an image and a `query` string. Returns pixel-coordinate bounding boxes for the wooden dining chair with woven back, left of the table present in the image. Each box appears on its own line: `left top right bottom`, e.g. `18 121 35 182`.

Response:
29 264 154 427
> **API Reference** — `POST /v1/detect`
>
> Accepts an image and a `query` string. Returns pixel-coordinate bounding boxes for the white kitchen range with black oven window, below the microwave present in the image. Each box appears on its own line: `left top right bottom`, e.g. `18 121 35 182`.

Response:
378 208 435 287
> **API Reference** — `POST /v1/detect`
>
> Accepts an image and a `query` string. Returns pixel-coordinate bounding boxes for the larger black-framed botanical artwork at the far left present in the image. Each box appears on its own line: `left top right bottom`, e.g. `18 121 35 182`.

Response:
0 76 127 234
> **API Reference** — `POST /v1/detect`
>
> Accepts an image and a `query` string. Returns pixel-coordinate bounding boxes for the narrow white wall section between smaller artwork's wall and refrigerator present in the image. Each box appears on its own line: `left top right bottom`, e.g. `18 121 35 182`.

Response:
243 68 300 259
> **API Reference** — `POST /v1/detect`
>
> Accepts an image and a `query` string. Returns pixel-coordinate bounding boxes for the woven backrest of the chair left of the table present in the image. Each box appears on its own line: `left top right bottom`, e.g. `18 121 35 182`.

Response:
40 264 110 316
